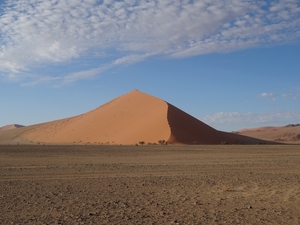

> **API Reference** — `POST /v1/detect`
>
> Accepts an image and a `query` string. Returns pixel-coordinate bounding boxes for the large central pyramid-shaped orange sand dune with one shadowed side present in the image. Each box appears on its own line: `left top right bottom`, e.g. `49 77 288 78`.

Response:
0 90 278 144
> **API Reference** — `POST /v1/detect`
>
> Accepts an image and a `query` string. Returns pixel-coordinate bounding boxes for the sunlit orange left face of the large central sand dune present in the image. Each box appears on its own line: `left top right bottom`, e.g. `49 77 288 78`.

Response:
24 90 170 144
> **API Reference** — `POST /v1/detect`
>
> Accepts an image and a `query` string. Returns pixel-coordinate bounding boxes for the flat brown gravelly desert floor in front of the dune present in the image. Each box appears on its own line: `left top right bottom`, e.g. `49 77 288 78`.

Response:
0 145 300 224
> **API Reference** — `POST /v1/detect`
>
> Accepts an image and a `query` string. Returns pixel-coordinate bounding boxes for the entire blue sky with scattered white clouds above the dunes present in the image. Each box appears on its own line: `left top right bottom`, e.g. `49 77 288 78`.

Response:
0 0 300 131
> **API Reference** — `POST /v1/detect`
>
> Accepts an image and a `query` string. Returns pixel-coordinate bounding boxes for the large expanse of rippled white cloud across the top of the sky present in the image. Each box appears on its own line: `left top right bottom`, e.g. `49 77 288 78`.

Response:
0 0 300 82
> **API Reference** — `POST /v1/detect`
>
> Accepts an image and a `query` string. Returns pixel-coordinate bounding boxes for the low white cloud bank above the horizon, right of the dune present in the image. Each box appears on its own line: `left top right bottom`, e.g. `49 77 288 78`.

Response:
202 111 300 127
